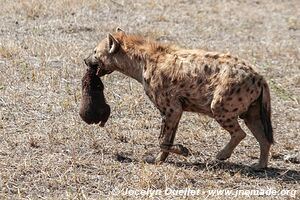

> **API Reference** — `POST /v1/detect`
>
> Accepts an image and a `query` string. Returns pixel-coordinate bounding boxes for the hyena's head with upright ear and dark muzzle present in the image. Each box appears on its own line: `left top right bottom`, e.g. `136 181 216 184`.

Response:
84 28 123 76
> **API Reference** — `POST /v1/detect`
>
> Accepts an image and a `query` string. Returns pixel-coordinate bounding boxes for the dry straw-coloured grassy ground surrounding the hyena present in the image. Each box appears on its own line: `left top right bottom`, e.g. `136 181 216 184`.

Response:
0 0 300 199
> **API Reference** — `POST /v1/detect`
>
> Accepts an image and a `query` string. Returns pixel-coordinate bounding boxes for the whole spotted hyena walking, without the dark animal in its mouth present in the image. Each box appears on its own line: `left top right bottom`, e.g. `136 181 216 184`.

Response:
85 29 273 168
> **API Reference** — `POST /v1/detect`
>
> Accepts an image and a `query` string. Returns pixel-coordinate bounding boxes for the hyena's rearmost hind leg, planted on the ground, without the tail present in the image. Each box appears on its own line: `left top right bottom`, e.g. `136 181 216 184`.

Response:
241 102 272 169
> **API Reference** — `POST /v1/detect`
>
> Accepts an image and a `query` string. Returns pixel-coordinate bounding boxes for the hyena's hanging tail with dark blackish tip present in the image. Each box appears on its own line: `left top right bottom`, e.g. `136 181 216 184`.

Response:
258 84 274 144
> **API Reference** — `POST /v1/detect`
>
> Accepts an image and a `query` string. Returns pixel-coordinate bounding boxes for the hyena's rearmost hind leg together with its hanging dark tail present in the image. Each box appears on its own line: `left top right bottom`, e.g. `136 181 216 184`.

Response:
243 84 274 169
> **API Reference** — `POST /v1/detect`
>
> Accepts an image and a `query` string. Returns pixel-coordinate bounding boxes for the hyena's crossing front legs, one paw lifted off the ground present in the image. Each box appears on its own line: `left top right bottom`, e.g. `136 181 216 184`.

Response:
155 108 188 163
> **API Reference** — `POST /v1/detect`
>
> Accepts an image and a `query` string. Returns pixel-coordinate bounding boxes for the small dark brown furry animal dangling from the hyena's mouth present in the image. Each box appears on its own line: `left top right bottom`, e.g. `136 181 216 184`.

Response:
79 68 110 127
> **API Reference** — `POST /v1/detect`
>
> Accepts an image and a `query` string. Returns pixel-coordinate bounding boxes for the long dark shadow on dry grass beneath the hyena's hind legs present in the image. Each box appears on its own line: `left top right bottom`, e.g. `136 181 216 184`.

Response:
169 161 300 183
